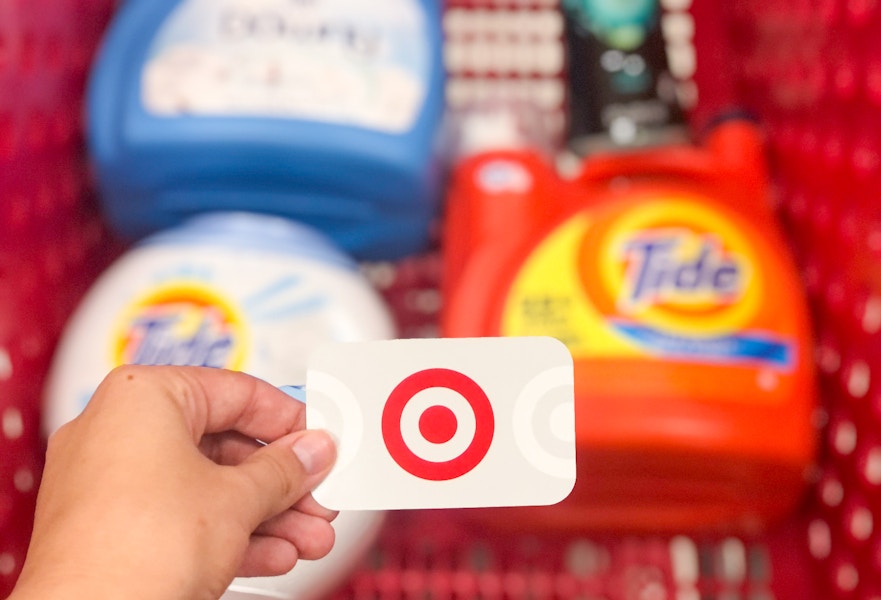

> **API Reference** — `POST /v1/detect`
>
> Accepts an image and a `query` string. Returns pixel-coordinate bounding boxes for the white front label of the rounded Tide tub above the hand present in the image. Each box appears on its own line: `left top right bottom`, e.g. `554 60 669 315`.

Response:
44 245 394 433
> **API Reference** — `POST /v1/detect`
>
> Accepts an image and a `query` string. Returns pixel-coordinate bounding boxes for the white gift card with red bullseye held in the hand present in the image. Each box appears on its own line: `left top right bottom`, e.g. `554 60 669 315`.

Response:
306 337 575 510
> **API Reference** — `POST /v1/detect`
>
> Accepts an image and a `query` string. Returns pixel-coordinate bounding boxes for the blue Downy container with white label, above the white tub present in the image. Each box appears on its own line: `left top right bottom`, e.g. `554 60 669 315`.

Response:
88 0 444 259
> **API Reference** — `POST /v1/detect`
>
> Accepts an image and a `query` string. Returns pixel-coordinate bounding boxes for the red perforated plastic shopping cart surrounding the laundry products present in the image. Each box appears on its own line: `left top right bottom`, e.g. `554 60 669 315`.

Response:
0 0 881 600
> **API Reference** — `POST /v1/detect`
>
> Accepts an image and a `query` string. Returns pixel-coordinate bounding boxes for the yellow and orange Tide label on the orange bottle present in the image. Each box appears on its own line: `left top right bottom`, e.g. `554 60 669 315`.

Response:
500 190 803 406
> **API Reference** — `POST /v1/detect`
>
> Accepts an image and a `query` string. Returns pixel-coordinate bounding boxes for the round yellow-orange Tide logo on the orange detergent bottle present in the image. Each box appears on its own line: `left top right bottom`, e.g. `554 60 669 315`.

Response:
579 198 763 336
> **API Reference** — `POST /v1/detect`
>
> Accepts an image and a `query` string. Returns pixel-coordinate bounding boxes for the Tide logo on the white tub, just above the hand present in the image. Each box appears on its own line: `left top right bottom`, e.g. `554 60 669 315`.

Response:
113 282 246 370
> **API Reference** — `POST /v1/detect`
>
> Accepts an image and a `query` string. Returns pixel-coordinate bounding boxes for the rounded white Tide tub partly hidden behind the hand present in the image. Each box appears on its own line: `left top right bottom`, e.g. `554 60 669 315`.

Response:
43 213 395 600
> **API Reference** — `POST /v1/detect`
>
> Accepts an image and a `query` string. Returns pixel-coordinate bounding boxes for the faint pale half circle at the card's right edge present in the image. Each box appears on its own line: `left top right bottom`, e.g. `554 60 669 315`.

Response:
513 367 575 479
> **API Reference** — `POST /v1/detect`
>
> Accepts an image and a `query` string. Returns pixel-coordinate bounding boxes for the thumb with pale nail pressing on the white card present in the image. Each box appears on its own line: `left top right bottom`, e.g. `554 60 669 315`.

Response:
236 430 336 527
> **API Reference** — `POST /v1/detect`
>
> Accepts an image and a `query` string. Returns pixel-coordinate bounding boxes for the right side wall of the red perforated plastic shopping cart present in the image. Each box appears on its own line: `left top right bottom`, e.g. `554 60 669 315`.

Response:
731 0 881 600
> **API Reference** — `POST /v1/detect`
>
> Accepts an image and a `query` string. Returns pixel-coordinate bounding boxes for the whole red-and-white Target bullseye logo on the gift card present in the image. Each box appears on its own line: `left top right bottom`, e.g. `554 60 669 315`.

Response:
382 368 495 481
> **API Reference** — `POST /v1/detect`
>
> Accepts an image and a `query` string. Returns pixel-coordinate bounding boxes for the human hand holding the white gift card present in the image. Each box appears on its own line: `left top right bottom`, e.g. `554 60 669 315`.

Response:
11 366 336 600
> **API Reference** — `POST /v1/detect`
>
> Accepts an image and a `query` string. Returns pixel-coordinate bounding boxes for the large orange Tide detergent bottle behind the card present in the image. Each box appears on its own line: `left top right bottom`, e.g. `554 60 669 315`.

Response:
442 119 815 533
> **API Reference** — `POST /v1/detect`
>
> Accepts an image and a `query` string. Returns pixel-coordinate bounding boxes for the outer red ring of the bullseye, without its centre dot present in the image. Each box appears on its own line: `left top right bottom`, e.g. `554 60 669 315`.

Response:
382 369 495 481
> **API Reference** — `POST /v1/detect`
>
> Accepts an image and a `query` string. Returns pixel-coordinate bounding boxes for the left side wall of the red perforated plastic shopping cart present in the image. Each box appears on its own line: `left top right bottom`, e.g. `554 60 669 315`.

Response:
0 0 112 597
